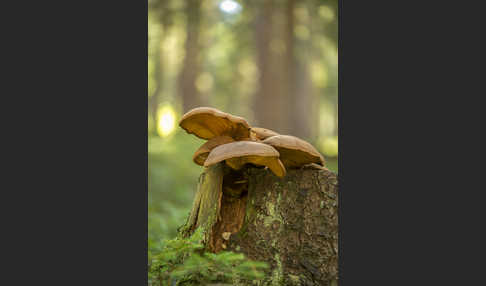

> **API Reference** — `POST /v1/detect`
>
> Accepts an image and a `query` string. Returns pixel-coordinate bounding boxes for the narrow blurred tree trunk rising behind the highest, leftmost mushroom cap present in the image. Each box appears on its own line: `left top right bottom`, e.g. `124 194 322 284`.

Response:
179 0 205 112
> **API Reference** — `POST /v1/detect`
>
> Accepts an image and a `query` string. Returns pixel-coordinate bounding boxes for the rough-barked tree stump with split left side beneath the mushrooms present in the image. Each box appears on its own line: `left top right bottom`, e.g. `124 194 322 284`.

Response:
181 163 338 285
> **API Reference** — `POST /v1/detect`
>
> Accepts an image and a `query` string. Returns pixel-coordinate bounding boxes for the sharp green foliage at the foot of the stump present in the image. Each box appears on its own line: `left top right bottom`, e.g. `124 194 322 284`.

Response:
148 229 268 286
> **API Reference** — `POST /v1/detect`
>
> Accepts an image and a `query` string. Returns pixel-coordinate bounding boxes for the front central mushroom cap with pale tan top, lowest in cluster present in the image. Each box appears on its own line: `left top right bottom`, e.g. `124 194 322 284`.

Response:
204 141 286 177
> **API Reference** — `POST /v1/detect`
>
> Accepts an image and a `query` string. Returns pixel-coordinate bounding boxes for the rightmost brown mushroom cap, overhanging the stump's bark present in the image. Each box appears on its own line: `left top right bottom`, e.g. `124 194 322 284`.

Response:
262 135 325 168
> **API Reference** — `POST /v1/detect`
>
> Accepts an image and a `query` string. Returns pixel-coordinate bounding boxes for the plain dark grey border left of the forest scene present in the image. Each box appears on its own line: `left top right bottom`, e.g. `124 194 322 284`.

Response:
0 1 148 285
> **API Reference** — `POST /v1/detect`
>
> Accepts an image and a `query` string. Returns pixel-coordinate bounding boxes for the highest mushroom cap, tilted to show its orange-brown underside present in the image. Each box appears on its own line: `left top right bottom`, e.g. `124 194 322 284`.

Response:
179 107 250 140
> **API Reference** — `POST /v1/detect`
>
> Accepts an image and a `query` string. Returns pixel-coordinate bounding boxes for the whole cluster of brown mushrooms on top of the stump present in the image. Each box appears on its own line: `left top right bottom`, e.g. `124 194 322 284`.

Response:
179 107 325 177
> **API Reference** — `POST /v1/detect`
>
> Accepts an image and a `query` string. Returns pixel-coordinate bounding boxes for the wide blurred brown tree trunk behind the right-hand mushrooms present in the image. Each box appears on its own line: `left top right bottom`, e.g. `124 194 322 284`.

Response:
254 0 317 141
